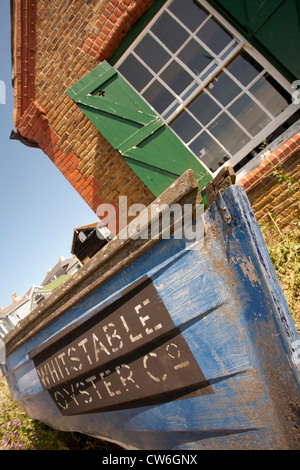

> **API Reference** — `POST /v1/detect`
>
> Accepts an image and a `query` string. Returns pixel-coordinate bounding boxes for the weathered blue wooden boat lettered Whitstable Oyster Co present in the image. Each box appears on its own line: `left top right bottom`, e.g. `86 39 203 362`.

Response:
2 170 300 450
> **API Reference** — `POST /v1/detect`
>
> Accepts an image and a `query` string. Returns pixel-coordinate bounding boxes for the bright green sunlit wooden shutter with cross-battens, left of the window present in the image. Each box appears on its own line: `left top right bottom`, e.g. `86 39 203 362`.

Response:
67 62 212 196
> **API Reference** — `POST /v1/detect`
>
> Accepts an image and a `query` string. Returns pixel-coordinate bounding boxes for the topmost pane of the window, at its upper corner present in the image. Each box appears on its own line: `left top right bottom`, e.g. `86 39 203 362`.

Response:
169 0 208 31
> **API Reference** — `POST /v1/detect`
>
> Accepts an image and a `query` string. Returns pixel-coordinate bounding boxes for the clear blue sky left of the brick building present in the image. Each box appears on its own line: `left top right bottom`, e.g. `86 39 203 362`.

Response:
0 0 98 308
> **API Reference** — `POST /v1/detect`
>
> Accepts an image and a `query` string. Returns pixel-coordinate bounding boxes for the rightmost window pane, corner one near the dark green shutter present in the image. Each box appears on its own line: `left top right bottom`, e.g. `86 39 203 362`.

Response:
250 74 290 116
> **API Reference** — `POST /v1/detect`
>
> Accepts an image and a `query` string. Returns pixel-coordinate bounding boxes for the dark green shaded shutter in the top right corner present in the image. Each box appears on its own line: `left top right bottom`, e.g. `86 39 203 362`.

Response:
208 0 300 82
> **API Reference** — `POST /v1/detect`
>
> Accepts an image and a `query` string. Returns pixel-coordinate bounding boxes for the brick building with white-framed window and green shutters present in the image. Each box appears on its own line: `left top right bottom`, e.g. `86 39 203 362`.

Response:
11 0 300 235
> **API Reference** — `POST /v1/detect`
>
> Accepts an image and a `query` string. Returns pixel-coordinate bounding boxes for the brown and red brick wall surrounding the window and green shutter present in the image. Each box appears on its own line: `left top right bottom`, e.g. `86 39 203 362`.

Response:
13 0 300 235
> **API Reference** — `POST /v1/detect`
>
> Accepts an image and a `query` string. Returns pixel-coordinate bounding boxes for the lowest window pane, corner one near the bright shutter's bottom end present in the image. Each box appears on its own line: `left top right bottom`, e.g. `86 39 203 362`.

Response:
190 132 228 171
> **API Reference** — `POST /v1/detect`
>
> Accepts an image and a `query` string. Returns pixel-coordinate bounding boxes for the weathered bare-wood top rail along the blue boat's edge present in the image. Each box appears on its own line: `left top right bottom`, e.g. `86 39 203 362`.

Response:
3 170 201 356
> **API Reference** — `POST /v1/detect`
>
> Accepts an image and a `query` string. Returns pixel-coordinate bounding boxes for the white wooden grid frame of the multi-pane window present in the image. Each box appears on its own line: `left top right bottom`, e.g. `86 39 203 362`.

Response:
115 0 300 175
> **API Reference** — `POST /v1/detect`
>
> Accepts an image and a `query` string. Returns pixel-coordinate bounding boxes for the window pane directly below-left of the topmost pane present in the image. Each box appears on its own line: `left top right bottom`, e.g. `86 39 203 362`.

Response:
151 12 189 52
